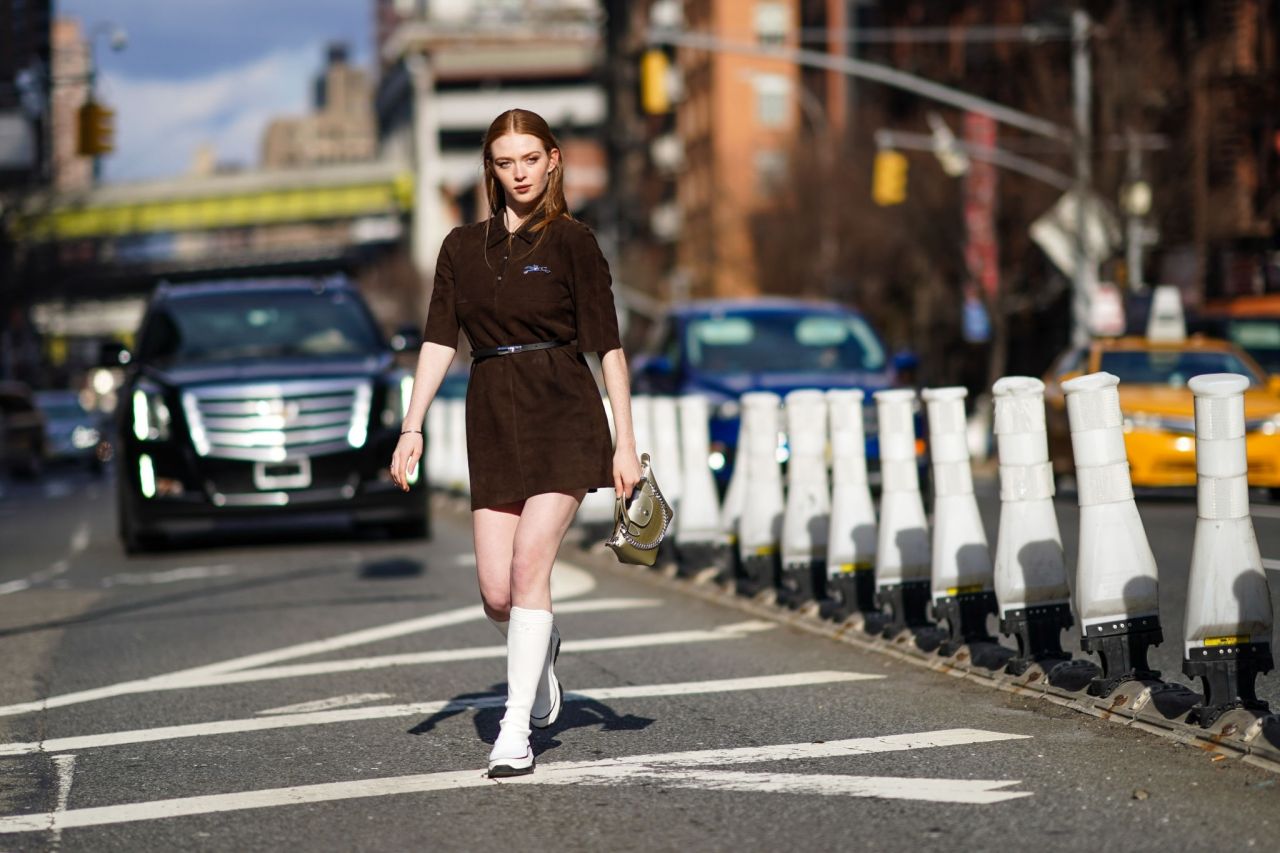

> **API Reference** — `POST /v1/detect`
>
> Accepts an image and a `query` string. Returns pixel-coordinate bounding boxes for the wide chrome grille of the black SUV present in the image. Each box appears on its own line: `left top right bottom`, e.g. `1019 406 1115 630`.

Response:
182 379 372 462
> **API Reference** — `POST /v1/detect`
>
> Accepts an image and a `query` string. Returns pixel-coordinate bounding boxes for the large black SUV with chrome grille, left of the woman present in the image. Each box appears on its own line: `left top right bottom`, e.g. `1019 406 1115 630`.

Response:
116 278 430 552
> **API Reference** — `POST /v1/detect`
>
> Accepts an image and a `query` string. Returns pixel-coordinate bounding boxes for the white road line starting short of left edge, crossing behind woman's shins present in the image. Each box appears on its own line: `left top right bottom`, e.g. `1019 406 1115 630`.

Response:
149 617 777 690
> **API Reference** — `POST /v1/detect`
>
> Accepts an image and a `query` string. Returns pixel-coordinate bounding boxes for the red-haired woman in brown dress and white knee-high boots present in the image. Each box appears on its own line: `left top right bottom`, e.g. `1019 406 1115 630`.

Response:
392 110 640 777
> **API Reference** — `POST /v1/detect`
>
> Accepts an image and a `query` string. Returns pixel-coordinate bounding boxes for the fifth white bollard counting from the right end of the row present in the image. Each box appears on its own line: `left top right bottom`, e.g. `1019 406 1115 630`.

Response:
874 388 931 637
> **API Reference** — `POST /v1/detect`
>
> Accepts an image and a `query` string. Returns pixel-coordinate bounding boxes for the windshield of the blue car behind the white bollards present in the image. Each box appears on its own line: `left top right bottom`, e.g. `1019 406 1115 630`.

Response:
685 314 884 374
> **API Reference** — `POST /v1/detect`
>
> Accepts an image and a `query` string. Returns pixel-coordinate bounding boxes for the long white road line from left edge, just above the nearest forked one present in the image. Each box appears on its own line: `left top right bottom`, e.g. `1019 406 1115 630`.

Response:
0 671 884 756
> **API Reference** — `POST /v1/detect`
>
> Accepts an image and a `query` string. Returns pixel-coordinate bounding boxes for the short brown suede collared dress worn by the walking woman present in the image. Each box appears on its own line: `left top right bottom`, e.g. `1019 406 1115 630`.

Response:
424 216 621 510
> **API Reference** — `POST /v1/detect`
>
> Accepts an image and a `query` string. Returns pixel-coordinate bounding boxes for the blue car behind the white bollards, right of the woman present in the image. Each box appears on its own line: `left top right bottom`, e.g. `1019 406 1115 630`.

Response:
632 298 913 488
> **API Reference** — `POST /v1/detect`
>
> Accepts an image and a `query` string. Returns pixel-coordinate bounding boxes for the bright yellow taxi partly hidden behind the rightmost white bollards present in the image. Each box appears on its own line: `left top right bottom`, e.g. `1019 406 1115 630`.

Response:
1044 336 1280 498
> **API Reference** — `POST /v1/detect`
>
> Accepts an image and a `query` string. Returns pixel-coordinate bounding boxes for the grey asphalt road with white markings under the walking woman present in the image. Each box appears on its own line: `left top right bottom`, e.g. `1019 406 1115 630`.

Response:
0 471 1280 852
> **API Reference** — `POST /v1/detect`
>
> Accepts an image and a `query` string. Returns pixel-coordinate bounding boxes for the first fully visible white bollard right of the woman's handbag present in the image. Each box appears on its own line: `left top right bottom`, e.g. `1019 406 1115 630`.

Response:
664 394 728 575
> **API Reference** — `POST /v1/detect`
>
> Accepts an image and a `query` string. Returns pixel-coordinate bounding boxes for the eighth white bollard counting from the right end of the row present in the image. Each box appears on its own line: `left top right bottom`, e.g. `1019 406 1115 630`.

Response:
737 391 783 596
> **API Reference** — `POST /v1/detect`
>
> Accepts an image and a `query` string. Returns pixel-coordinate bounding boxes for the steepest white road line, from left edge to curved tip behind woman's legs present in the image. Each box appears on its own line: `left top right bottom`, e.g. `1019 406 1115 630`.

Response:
0 564 622 717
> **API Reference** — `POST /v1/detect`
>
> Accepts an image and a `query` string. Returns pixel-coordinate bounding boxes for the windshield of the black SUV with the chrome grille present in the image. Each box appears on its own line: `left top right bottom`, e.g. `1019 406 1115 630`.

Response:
140 291 381 362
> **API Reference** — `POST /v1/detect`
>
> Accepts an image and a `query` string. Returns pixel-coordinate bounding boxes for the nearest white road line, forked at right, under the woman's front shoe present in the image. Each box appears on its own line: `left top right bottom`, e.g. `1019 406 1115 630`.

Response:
0 729 1030 834
